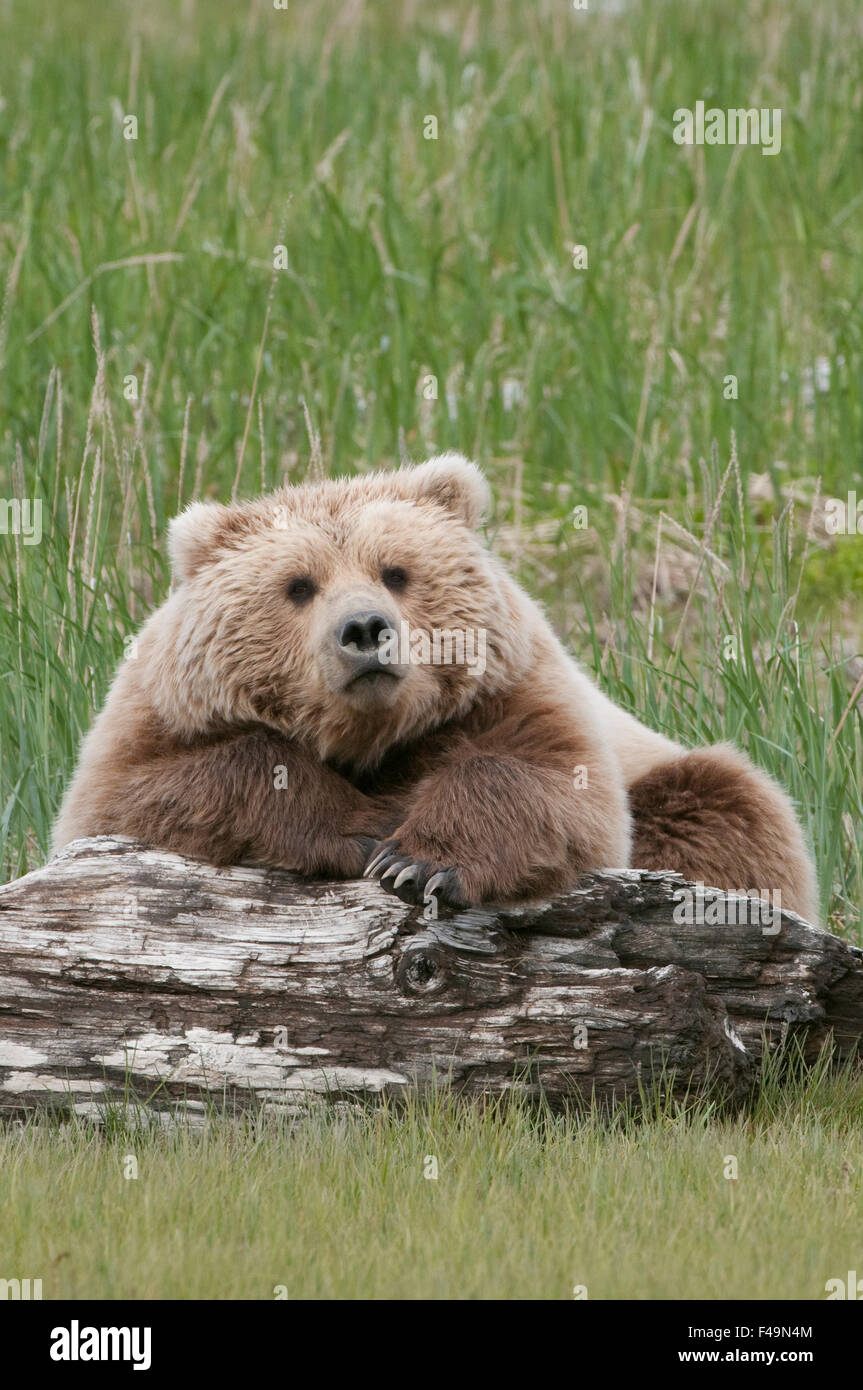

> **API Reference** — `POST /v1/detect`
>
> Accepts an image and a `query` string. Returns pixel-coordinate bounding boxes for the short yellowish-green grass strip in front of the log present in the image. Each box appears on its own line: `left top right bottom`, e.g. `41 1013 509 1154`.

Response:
0 1076 863 1300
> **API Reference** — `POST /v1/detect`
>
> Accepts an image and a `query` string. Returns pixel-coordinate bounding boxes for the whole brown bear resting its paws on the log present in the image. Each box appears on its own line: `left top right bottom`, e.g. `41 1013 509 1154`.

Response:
54 453 817 920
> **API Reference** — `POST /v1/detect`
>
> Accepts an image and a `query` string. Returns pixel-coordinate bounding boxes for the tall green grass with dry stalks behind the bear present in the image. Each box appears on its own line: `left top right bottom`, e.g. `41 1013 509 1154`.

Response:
0 0 863 938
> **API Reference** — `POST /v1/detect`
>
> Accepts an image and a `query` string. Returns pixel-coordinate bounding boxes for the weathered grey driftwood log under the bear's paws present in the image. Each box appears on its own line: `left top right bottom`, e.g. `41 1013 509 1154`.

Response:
0 837 863 1116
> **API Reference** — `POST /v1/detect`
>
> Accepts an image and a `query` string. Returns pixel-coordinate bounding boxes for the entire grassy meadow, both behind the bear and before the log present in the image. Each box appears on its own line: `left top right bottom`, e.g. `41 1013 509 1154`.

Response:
0 0 863 1298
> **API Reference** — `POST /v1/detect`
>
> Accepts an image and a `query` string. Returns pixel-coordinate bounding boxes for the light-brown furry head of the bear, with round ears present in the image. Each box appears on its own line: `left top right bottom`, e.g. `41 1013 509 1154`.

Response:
139 453 528 767
